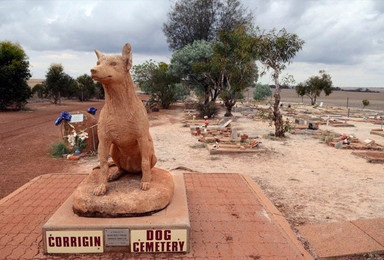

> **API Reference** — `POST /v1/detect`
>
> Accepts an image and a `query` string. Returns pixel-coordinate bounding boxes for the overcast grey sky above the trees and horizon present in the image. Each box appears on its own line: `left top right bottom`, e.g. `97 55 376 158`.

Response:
0 0 384 87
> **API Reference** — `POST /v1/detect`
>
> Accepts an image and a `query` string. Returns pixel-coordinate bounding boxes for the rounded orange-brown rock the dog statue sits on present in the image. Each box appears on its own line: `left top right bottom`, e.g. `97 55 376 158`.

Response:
73 166 174 217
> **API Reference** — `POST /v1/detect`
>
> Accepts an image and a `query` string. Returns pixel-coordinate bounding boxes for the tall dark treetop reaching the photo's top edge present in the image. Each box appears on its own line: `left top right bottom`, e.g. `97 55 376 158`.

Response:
163 0 253 50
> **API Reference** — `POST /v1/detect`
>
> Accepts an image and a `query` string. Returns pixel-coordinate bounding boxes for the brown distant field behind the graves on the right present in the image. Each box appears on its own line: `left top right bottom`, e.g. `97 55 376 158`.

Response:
247 88 384 111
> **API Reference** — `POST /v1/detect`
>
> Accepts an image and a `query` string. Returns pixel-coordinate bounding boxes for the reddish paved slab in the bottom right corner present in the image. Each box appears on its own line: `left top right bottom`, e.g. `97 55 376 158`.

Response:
298 219 384 258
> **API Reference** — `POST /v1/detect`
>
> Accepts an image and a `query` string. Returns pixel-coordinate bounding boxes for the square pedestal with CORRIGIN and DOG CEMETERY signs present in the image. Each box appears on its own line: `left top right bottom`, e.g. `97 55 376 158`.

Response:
43 174 190 254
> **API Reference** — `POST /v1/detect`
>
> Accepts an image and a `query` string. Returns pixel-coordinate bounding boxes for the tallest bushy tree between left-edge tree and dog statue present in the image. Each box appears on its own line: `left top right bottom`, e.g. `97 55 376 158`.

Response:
44 63 74 104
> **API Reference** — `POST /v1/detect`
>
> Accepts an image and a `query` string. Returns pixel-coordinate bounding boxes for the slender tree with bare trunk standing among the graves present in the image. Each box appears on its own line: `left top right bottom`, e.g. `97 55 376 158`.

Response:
258 28 304 137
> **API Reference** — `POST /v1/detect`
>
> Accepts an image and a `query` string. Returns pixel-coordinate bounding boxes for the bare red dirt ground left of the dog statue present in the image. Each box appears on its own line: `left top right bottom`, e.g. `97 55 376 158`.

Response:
0 100 104 198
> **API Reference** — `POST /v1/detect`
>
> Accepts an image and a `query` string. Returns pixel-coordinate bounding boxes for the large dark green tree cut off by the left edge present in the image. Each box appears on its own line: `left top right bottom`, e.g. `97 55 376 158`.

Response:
0 41 32 110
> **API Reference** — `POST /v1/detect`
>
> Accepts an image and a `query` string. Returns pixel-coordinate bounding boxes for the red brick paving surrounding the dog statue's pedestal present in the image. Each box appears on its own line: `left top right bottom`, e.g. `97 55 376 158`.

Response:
0 173 312 259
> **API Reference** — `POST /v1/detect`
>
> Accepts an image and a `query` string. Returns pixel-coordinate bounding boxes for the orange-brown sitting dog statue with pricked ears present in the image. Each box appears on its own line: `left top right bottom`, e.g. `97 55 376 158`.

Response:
91 43 157 196
